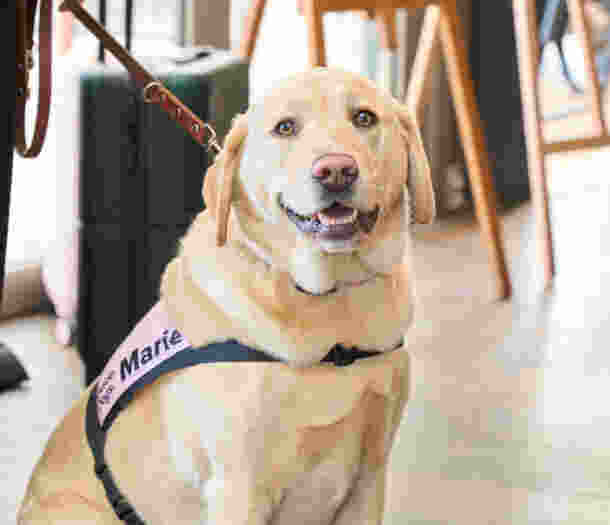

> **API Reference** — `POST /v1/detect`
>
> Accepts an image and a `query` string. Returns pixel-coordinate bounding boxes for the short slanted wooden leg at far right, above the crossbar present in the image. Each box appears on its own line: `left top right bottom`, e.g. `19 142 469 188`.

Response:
568 0 605 135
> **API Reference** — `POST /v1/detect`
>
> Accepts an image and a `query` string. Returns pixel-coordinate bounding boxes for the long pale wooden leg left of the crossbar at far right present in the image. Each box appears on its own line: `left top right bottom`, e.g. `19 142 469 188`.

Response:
513 0 555 287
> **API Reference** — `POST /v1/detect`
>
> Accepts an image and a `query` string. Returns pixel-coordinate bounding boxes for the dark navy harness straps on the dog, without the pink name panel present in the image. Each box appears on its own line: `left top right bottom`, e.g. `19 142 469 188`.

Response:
85 339 403 525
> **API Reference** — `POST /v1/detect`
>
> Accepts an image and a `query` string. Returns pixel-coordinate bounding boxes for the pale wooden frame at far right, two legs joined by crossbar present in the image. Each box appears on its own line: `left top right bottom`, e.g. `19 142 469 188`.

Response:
513 0 610 287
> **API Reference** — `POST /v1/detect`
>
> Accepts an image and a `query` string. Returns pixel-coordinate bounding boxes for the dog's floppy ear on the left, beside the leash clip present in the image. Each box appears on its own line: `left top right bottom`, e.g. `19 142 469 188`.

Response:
203 115 248 246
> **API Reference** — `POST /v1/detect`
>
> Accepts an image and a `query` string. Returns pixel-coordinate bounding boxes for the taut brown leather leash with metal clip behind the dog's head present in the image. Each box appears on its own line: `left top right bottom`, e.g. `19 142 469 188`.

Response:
58 0 221 153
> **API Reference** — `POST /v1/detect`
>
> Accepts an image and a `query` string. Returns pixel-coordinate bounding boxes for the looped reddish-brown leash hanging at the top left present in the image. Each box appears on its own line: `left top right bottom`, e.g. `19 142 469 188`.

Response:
15 0 53 158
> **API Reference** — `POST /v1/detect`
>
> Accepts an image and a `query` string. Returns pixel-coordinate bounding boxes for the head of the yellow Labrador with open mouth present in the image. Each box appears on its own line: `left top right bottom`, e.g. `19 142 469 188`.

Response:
204 68 435 294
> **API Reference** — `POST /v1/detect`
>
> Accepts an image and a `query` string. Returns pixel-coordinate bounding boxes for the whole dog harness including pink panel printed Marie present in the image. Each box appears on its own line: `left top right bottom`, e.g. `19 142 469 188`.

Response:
85 302 403 525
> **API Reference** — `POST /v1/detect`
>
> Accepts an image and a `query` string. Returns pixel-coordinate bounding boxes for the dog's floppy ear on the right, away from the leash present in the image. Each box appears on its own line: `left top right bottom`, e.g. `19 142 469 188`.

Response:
398 106 436 224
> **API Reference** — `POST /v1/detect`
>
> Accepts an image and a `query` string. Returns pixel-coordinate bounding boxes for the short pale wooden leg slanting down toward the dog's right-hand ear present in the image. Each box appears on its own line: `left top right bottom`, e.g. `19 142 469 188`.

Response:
405 6 440 117
